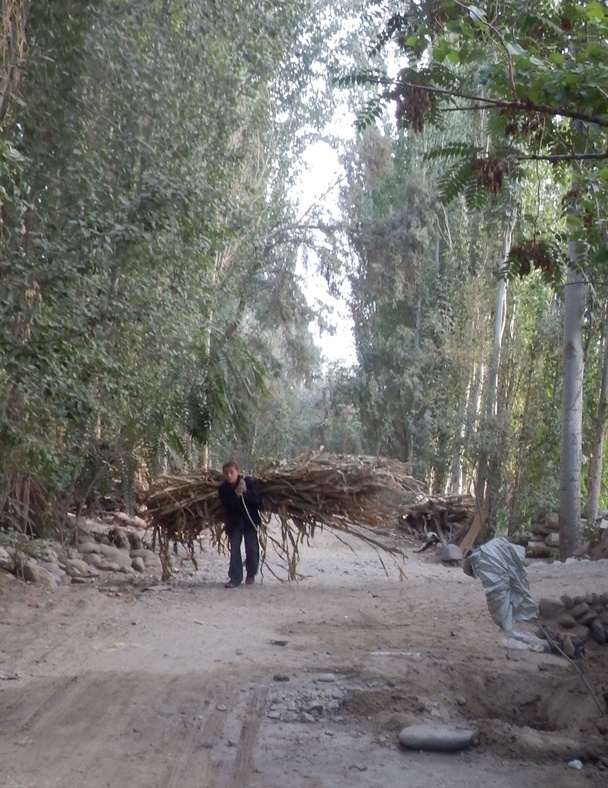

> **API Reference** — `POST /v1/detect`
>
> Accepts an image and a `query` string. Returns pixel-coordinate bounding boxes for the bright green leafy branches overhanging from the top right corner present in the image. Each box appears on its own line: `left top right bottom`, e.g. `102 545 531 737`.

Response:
346 0 608 235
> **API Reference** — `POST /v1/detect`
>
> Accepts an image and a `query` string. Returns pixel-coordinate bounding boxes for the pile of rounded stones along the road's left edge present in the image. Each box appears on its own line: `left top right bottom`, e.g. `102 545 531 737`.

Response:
0 519 161 588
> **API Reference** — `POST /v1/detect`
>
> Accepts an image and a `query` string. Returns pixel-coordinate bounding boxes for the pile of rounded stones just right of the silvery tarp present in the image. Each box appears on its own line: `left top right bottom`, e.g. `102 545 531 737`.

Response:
538 592 608 659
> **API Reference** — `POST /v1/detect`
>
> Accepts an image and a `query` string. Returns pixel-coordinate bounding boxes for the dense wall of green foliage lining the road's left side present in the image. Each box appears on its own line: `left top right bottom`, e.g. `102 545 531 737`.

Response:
0 0 356 528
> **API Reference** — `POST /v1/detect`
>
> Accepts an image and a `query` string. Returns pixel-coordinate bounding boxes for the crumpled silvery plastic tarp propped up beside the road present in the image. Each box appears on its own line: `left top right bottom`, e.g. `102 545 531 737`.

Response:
469 536 538 632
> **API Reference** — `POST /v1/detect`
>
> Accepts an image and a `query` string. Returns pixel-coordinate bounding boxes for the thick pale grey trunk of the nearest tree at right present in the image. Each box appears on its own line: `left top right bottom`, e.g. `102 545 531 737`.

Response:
559 254 587 561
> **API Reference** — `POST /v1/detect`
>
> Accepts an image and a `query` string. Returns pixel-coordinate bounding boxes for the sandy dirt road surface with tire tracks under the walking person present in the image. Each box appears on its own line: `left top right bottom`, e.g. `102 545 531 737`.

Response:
0 534 608 788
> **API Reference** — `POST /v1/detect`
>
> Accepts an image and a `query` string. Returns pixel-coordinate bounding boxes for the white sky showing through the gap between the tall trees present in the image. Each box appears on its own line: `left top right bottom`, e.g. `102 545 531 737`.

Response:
298 135 356 366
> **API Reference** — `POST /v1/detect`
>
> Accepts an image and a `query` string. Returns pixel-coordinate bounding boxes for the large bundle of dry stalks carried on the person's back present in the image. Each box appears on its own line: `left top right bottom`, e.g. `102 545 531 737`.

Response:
145 453 421 579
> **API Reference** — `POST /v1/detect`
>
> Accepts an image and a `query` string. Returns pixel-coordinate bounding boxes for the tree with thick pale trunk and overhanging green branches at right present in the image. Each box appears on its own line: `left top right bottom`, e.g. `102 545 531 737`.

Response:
346 0 608 558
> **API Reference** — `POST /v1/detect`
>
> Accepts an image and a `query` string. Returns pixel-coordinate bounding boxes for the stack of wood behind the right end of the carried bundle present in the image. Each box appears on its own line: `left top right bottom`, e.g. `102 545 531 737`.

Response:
397 495 476 545
